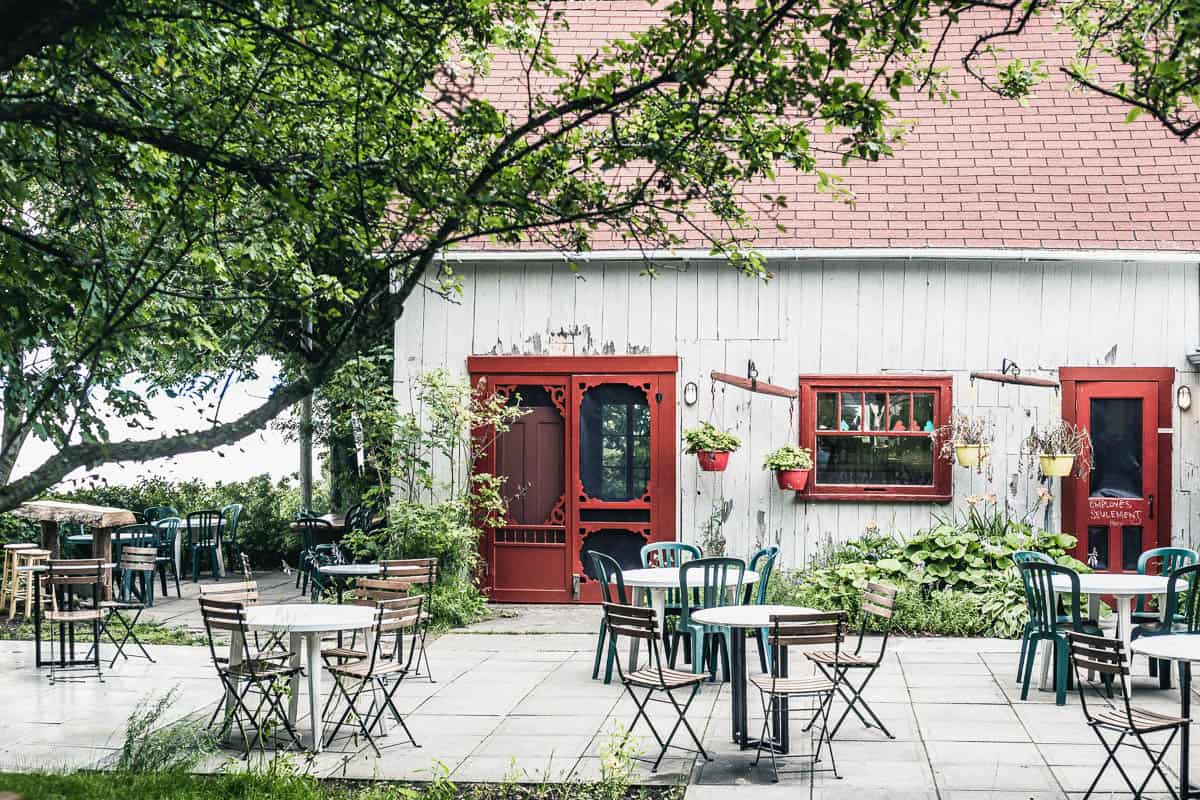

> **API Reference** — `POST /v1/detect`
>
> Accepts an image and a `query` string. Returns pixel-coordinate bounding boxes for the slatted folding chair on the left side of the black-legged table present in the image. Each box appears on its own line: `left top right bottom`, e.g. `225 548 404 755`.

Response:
604 603 713 772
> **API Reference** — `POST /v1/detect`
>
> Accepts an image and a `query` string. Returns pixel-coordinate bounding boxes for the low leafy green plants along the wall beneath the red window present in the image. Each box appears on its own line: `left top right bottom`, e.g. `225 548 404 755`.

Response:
768 495 1088 637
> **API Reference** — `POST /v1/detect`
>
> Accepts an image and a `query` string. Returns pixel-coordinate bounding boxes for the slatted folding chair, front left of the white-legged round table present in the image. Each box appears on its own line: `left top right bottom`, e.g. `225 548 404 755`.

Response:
200 597 302 758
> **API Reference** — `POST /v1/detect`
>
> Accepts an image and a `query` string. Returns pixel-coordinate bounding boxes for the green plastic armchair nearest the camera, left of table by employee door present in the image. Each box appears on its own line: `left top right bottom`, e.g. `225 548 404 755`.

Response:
1018 561 1102 705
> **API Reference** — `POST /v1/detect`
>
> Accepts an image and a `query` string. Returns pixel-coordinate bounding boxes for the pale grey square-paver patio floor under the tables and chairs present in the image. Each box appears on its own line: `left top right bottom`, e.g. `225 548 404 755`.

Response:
0 575 1200 800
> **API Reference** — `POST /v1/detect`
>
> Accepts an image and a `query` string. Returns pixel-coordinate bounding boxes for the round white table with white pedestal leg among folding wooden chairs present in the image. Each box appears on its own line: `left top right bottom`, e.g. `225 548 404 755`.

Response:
238 603 376 753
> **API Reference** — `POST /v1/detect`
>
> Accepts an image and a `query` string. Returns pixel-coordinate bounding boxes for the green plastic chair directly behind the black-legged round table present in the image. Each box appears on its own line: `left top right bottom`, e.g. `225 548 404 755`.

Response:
671 558 746 680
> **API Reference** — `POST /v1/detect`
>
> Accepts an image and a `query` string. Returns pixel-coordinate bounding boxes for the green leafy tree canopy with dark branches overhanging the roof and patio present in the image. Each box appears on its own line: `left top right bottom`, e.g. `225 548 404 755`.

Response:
0 0 1196 510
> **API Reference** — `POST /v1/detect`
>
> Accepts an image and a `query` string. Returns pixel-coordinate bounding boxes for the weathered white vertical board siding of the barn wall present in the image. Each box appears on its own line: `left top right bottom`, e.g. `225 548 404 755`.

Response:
395 254 1200 565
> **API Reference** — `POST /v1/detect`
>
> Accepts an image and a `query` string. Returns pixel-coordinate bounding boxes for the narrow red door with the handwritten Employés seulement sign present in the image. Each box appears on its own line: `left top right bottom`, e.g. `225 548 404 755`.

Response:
1068 380 1169 572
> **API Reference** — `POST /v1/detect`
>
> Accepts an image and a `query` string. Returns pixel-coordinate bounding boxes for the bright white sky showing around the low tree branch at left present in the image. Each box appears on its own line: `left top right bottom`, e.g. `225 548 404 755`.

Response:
13 359 320 491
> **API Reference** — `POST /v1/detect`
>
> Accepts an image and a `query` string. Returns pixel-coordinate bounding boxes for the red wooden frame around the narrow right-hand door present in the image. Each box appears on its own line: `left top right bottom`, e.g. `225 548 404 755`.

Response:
1058 367 1175 567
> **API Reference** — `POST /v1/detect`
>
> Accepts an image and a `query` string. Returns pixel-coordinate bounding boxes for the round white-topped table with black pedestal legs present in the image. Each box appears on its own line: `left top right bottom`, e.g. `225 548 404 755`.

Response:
691 604 817 753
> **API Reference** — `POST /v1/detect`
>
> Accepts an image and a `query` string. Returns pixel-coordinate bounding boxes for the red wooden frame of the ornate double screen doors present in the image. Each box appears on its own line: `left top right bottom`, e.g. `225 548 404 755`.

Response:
467 355 679 602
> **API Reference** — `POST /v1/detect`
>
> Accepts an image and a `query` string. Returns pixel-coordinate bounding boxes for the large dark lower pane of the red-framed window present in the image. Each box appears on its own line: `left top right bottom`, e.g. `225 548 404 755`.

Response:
816 435 934 486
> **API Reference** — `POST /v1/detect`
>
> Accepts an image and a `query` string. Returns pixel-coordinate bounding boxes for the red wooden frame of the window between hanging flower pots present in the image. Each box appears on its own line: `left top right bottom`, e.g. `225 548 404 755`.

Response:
799 374 954 503
